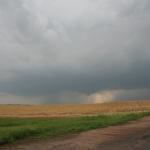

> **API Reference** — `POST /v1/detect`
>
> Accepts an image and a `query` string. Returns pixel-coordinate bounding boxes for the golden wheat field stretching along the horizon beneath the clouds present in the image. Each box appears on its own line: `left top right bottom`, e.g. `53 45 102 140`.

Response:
0 101 150 118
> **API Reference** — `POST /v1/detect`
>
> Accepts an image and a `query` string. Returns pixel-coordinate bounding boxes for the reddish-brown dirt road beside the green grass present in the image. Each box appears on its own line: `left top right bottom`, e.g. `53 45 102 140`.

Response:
0 117 150 150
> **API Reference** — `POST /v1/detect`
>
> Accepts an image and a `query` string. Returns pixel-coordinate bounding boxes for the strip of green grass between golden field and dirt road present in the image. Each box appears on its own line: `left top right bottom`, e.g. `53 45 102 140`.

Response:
0 112 150 144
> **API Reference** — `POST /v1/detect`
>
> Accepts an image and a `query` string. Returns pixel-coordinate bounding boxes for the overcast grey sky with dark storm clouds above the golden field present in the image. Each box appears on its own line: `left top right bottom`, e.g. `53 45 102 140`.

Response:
0 0 150 104
